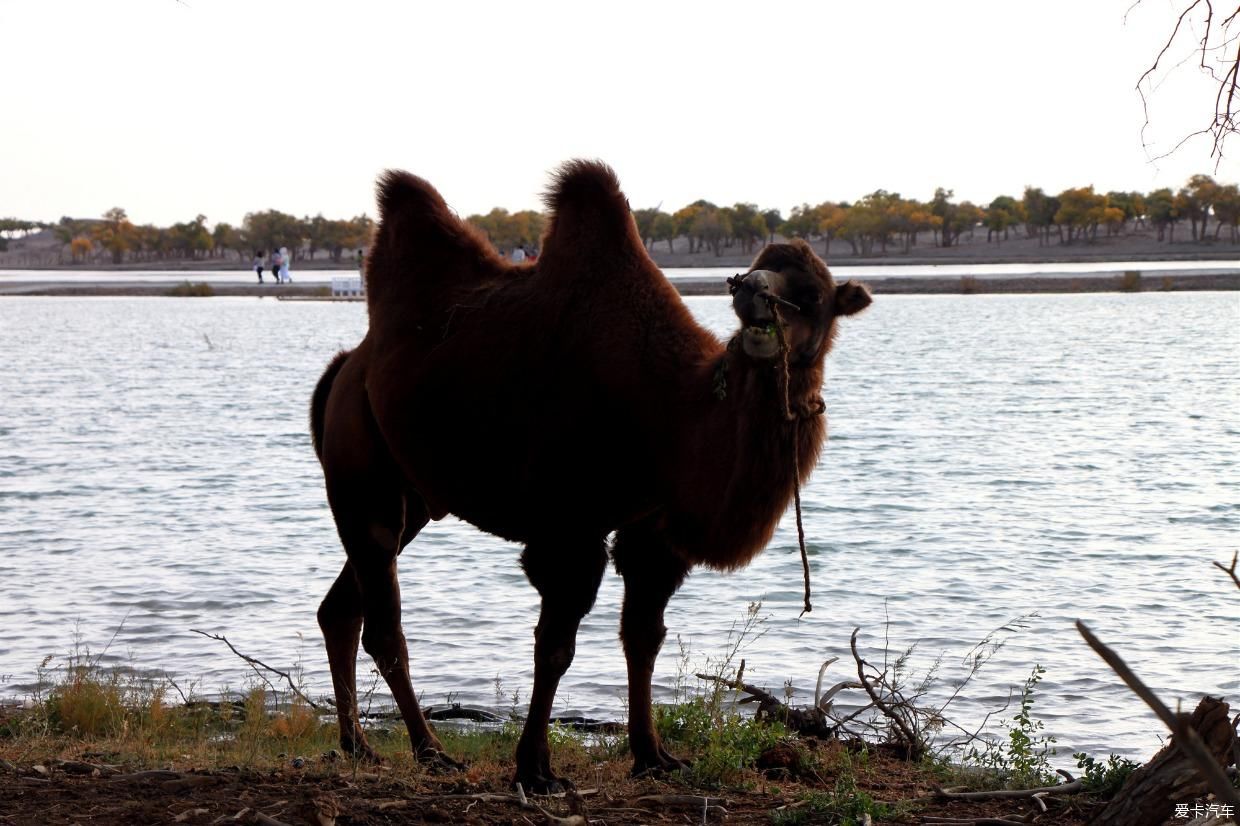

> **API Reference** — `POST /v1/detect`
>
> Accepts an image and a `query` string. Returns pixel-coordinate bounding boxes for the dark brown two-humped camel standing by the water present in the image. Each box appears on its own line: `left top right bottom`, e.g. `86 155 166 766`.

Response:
310 161 870 793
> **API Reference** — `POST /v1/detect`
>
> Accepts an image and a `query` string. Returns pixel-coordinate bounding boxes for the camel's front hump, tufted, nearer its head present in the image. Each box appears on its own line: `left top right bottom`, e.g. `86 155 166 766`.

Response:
542 160 645 259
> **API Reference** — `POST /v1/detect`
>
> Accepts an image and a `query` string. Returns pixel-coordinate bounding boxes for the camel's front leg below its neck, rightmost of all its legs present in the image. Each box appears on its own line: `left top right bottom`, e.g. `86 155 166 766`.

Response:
611 526 688 776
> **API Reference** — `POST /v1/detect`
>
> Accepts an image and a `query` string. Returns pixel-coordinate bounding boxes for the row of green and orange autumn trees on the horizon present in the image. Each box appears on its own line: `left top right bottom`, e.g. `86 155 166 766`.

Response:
0 175 1240 263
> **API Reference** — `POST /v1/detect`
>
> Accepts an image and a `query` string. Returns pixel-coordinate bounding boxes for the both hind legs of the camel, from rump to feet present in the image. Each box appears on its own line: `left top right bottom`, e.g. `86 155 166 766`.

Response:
319 349 460 768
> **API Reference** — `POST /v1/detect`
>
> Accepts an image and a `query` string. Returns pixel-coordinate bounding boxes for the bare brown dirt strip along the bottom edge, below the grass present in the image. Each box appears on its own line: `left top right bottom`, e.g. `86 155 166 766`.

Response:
0 755 1090 826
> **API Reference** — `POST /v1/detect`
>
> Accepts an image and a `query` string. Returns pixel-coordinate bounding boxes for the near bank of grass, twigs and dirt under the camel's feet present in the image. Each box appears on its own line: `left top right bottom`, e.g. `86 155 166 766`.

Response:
0 597 1226 826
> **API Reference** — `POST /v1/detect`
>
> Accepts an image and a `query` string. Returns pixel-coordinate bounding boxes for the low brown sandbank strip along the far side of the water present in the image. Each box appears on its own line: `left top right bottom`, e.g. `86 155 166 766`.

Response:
0 270 1240 296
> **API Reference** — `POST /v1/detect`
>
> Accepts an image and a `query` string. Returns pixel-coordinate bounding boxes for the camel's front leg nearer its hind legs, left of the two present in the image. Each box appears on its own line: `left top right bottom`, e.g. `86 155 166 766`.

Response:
512 538 608 794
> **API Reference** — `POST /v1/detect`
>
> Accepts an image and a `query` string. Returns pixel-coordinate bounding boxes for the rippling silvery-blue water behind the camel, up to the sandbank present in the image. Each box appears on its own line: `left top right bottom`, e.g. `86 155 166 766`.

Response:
0 293 1240 757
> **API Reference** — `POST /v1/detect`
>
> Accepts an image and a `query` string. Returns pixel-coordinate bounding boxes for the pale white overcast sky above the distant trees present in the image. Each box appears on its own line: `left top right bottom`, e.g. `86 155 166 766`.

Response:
0 0 1240 226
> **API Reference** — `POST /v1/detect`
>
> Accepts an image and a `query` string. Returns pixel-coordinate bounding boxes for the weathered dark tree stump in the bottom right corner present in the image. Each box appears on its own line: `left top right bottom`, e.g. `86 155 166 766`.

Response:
1090 697 1236 826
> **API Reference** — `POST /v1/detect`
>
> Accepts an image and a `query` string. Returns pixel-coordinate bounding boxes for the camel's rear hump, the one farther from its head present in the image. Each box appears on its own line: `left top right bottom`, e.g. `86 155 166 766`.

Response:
366 170 498 308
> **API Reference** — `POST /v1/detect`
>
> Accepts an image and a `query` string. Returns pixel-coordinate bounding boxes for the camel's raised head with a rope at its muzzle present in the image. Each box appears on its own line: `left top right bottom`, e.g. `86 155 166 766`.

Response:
728 239 870 367
